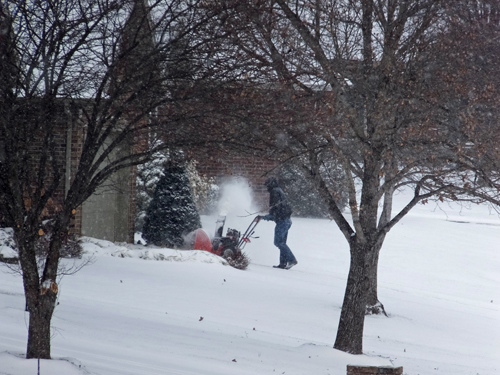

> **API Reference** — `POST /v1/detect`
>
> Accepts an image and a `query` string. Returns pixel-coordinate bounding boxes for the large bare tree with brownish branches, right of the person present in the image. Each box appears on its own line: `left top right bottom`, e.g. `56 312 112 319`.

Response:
213 0 499 354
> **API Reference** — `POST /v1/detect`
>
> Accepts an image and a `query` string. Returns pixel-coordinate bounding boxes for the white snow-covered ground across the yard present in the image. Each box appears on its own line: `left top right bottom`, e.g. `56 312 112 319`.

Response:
0 189 500 375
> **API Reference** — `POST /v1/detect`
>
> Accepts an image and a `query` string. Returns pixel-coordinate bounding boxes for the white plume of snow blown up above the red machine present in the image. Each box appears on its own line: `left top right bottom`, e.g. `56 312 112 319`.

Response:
217 178 257 216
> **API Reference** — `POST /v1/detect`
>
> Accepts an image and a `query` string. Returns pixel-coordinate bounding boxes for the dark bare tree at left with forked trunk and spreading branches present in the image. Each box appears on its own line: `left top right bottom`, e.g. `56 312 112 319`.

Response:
0 0 224 358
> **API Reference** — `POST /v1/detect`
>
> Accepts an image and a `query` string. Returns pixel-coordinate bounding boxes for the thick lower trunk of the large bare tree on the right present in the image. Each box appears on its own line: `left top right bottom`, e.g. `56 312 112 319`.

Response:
333 239 368 354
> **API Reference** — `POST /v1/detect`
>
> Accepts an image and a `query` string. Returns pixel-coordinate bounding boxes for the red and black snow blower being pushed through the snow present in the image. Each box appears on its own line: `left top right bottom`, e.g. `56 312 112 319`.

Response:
187 216 259 269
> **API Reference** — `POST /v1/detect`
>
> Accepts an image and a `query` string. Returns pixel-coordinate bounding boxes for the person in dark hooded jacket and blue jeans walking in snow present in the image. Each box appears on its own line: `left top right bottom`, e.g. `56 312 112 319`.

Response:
258 177 297 270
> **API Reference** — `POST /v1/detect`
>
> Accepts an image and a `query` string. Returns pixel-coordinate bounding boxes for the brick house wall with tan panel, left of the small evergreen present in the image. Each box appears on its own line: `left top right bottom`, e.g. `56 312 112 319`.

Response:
0 100 135 241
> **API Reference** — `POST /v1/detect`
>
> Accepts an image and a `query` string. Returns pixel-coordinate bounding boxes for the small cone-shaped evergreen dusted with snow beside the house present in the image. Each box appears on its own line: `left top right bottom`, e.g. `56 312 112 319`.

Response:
142 163 201 248
